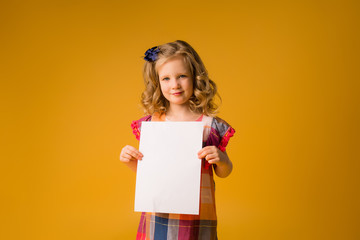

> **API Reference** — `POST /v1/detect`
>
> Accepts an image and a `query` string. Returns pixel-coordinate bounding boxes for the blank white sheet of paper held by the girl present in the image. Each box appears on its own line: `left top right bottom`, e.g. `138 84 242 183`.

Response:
135 122 203 214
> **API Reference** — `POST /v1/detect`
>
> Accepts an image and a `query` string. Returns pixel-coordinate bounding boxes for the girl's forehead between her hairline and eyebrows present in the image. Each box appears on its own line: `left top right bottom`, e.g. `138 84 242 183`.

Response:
157 56 190 75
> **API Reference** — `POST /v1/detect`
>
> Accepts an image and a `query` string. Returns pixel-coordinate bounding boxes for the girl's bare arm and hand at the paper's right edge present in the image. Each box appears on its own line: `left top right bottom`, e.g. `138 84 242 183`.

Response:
198 146 233 178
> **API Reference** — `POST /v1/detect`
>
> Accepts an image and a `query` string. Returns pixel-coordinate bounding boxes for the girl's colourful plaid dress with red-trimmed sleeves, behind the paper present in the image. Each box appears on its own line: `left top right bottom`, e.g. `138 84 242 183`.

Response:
131 114 235 240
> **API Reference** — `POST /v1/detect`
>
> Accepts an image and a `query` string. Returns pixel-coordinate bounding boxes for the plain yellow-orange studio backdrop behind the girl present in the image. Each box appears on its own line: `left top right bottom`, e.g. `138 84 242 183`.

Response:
0 0 360 240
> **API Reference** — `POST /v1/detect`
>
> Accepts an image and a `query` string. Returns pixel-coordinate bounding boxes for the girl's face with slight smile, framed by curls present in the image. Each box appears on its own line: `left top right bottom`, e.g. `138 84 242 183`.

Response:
158 56 194 107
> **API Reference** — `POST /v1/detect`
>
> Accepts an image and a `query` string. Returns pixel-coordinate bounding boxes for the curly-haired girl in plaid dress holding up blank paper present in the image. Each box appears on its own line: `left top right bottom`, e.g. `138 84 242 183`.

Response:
120 40 235 240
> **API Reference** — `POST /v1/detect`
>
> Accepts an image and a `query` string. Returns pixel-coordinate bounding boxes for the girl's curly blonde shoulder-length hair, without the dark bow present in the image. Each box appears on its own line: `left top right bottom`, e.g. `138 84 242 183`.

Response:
141 40 221 116
